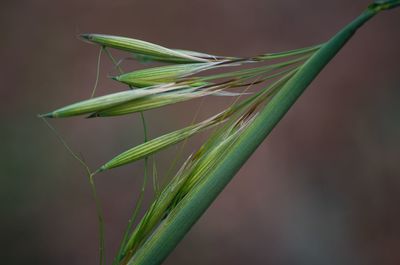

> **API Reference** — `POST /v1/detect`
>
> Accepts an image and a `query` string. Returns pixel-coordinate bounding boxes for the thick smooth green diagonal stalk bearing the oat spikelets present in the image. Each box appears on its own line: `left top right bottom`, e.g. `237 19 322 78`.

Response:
128 4 398 265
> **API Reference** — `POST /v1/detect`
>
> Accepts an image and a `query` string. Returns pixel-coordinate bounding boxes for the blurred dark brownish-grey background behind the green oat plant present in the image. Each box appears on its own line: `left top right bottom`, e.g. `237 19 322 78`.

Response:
0 0 400 265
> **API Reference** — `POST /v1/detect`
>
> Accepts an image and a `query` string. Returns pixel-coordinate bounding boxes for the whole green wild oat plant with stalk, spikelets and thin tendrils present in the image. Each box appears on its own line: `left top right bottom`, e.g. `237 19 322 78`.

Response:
40 0 400 265
